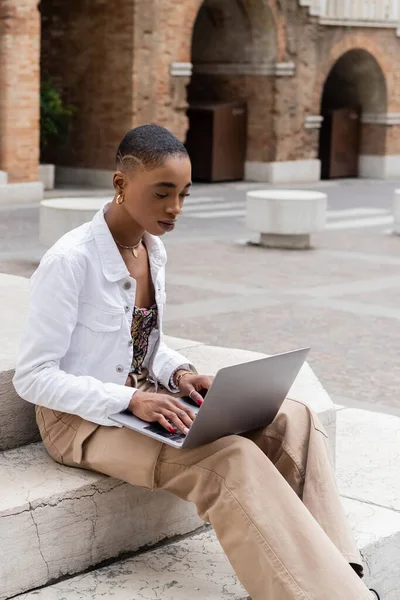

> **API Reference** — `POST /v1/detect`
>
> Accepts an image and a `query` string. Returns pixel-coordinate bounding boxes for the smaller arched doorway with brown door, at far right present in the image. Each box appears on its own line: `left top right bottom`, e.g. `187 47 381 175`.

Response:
319 49 387 179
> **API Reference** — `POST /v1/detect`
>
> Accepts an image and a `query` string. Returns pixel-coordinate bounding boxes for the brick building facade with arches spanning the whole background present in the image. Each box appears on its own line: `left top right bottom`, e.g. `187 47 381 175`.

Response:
0 0 400 181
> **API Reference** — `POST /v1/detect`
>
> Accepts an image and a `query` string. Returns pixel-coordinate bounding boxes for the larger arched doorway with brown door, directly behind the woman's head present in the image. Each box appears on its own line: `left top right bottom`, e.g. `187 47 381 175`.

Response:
187 0 276 181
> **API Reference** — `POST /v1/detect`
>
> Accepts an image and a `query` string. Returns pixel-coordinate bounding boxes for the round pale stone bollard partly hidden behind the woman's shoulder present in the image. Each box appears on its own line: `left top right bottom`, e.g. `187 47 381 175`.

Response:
39 198 112 248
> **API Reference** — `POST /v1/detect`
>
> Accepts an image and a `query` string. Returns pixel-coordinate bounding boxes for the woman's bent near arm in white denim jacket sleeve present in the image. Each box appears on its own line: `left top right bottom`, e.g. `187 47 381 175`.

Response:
13 254 136 425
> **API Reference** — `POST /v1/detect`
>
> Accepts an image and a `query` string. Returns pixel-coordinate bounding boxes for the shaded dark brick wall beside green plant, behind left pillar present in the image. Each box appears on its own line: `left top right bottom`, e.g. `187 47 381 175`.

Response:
40 0 134 169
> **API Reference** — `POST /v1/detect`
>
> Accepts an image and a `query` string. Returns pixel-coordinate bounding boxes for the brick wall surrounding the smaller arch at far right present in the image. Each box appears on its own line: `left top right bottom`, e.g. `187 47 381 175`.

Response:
275 1 400 160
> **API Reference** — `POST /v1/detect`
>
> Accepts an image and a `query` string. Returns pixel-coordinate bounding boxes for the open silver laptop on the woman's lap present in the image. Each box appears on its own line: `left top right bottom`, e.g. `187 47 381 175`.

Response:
110 348 310 448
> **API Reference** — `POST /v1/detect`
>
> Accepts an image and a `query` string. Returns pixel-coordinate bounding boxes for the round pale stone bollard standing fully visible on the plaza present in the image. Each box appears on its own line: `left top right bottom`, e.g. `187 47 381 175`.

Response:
247 190 328 250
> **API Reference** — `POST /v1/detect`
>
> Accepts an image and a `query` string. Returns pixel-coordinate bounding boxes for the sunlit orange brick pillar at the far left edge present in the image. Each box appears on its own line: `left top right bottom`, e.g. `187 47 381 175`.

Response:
0 0 40 183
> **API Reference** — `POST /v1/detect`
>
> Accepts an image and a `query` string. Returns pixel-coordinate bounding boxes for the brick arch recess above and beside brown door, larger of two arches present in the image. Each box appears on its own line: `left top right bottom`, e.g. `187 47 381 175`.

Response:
188 0 281 179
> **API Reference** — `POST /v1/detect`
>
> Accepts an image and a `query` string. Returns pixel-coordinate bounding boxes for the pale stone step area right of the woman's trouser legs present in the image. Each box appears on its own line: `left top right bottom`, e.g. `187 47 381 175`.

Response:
336 409 400 600
